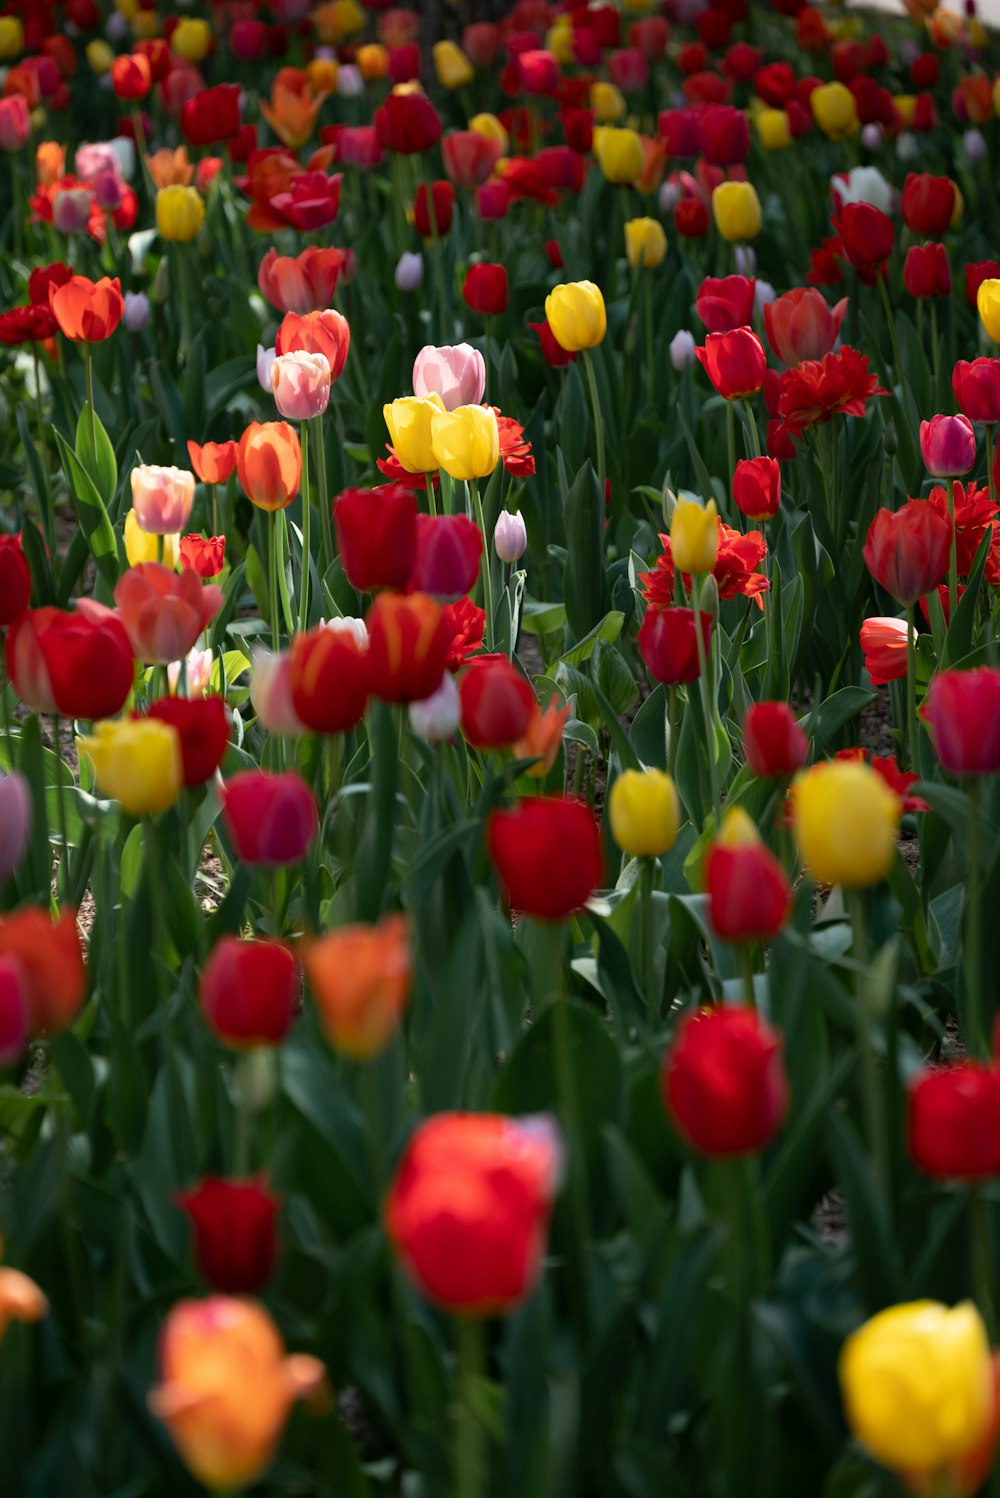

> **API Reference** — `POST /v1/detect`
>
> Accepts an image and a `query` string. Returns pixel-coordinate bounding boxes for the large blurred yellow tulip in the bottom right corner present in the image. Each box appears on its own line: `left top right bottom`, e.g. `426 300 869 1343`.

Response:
838 1300 993 1491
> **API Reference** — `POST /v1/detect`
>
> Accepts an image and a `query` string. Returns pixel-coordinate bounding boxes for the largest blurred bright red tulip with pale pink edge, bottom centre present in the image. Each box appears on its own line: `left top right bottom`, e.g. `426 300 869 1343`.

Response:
385 1113 561 1317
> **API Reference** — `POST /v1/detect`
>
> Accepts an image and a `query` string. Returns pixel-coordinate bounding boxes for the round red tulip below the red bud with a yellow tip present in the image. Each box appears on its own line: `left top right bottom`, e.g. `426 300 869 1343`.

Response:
660 1005 789 1158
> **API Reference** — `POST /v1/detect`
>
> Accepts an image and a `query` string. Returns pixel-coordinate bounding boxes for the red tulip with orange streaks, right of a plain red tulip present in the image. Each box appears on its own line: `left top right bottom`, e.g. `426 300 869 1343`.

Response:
367 593 451 703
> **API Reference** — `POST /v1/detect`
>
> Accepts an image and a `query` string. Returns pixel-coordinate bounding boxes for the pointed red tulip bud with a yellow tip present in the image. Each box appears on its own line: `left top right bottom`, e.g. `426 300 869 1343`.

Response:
704 806 792 942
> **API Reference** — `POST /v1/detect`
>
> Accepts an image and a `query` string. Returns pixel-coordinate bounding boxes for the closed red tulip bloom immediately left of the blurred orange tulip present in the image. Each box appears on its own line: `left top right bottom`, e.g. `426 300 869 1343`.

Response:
198 936 299 1048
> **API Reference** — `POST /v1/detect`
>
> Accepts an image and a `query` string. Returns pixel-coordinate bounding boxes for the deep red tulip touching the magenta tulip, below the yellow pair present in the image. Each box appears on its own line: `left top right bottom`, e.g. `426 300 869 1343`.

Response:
334 484 419 593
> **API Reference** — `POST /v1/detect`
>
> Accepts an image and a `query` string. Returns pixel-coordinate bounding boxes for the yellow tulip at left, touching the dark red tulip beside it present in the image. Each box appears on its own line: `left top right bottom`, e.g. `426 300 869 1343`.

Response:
79 718 184 816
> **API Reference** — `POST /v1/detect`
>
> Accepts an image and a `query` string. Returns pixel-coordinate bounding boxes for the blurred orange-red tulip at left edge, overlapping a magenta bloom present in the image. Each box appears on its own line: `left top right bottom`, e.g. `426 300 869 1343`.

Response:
0 905 87 1035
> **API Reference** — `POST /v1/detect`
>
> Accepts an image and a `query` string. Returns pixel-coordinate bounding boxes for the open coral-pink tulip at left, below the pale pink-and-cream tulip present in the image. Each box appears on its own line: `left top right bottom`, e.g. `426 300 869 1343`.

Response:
115 562 222 665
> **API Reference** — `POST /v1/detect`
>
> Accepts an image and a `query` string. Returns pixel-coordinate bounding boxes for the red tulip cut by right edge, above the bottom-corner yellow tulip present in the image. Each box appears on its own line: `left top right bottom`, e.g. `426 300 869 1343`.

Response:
907 1061 1000 1180
